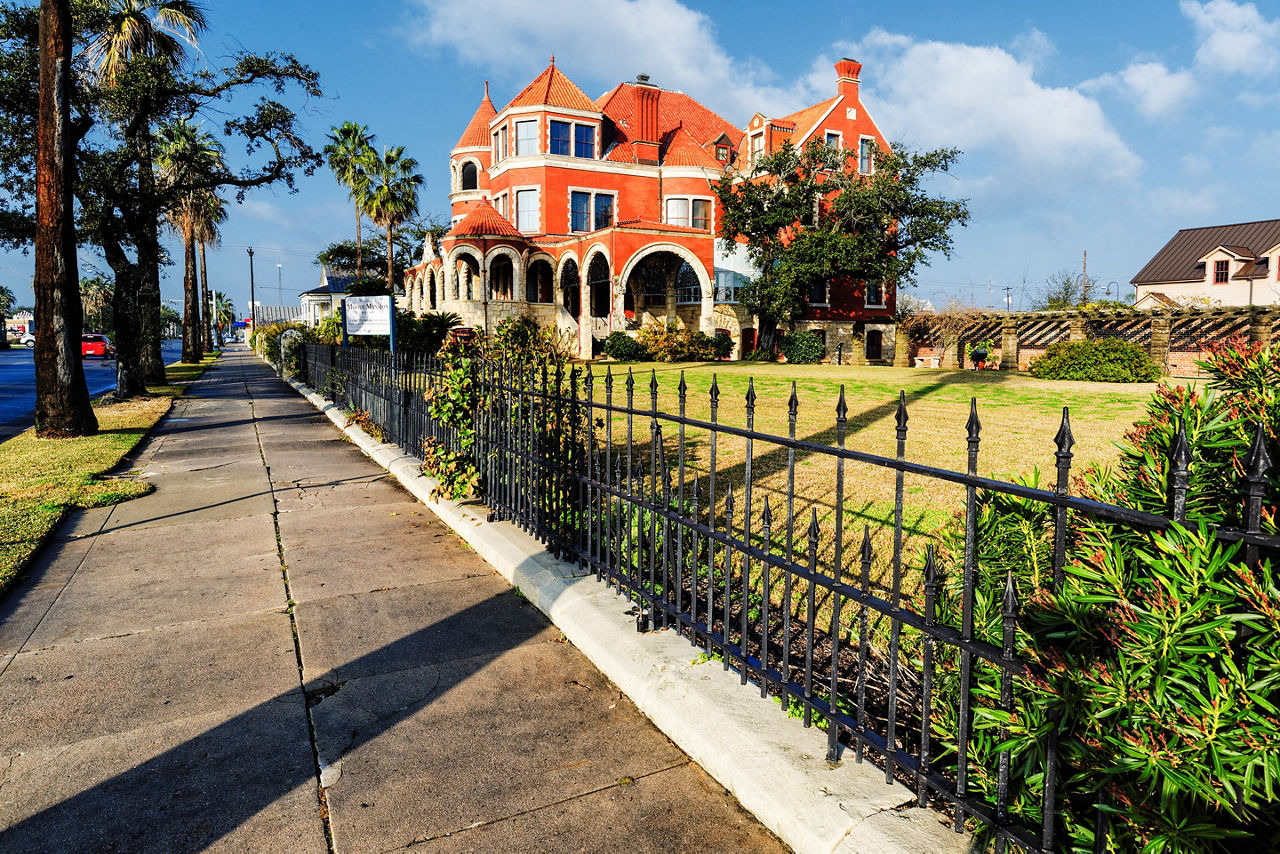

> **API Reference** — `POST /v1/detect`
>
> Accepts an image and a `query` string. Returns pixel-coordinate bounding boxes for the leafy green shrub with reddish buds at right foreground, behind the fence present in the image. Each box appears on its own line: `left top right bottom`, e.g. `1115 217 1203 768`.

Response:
934 342 1280 851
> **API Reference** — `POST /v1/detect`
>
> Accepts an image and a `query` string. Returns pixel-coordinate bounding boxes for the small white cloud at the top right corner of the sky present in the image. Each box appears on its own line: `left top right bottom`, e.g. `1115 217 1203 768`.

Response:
1179 0 1280 77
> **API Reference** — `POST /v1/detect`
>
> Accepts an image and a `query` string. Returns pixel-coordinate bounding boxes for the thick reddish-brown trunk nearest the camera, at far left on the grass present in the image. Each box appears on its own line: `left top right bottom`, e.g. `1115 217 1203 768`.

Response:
32 0 97 438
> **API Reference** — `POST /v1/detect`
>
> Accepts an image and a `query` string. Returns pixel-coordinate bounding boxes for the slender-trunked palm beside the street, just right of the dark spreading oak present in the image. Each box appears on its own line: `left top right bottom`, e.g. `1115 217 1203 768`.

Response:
156 119 227 364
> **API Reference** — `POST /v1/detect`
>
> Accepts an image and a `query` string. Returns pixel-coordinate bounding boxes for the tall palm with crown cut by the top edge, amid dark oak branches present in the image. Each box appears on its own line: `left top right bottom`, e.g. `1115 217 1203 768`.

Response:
87 0 207 384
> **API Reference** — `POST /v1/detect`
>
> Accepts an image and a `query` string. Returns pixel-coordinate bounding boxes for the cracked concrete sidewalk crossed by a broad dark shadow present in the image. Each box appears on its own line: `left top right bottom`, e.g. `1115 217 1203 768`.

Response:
0 351 782 851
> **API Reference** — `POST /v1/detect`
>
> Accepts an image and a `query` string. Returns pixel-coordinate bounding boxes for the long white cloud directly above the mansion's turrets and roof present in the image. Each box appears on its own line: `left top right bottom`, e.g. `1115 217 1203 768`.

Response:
413 0 835 124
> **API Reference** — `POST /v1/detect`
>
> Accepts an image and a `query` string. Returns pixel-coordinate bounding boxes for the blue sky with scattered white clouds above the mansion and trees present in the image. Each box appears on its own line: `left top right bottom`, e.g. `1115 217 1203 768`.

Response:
0 0 1280 317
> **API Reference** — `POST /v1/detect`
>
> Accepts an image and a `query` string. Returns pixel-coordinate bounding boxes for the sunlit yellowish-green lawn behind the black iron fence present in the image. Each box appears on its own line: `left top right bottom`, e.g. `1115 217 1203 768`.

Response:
581 362 1155 606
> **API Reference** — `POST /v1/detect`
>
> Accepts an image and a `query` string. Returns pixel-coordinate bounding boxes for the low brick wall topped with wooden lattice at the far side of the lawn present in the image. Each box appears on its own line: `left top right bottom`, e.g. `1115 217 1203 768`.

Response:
909 306 1280 376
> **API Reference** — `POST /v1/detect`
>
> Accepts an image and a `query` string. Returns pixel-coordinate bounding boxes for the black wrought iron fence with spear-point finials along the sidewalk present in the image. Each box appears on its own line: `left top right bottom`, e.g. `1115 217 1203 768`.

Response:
293 344 1280 851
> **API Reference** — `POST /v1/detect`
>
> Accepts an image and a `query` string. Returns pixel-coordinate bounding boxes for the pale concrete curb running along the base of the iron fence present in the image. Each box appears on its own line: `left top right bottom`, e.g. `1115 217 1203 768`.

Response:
285 380 969 854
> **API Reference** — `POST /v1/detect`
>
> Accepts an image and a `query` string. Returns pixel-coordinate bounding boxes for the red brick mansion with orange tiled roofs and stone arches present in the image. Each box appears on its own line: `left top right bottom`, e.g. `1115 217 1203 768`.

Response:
406 58 893 361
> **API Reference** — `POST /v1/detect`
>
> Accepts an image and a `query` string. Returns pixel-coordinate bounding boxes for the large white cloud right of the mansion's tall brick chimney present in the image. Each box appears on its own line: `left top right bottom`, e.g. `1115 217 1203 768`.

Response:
837 29 1140 178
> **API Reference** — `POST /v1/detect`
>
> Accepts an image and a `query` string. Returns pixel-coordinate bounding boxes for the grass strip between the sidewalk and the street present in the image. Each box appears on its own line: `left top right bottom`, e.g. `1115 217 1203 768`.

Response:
0 356 216 595
